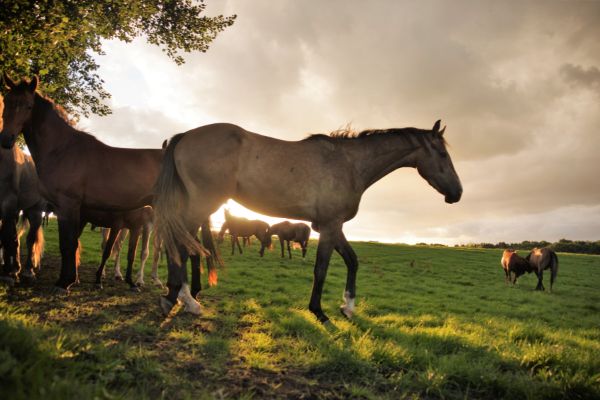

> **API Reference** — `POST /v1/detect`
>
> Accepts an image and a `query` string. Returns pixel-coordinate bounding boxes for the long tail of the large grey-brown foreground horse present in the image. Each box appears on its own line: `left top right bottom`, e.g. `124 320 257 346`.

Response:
154 133 209 264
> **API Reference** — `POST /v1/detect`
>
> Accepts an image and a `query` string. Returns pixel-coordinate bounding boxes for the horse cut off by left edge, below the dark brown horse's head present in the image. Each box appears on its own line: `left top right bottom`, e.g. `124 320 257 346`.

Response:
0 147 45 283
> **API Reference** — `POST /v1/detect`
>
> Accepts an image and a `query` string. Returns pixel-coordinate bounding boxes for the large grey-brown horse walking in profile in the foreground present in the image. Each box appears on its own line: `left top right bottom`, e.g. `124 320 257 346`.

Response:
155 121 462 323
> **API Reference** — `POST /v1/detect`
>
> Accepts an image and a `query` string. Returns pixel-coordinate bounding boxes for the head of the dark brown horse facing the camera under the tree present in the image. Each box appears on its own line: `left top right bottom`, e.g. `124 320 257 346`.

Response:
0 72 39 149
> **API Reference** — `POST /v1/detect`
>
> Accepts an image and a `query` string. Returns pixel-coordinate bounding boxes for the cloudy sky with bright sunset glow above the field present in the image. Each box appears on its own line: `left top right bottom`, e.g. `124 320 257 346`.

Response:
80 0 600 244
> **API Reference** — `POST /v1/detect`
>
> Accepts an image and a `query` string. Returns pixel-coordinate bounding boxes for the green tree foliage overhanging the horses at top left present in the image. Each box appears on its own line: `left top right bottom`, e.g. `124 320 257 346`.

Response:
0 0 236 116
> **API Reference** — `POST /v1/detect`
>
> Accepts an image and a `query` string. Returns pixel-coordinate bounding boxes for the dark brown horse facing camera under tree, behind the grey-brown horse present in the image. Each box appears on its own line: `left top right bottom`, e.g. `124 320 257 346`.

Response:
0 73 219 306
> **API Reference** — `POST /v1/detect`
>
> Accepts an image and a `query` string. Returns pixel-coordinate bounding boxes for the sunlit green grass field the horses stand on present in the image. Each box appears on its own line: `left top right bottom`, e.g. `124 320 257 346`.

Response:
0 221 600 399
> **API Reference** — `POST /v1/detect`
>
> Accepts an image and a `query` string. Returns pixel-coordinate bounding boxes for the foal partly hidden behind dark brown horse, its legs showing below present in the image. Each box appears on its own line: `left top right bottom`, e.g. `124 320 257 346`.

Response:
87 206 154 290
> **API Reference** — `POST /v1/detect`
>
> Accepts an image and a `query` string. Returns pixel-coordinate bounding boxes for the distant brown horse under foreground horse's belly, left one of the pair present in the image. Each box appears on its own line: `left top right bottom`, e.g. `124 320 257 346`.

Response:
218 210 271 257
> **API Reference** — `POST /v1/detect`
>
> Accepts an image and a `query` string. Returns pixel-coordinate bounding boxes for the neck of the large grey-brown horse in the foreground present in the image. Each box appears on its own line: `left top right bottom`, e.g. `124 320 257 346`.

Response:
343 134 420 189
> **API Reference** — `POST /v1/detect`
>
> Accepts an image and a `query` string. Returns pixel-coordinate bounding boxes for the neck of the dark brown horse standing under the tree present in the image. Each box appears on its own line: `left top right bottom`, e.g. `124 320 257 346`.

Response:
23 93 78 163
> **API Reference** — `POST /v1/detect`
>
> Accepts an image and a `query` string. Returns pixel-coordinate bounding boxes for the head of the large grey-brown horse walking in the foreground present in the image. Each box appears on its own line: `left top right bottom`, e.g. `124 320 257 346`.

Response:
417 120 462 204
